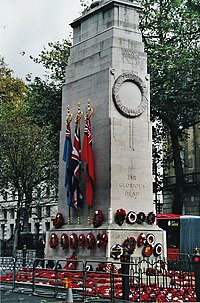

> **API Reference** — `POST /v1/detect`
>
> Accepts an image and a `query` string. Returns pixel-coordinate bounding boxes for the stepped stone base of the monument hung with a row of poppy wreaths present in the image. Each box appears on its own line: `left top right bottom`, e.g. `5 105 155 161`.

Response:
46 223 167 263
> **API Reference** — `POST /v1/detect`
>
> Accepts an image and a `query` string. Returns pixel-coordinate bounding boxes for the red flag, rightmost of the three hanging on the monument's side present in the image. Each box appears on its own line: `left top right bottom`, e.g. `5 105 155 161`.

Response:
81 119 94 209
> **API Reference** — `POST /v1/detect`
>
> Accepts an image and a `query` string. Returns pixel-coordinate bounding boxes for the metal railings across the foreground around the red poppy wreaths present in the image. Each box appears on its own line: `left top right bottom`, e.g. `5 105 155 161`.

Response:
0 256 200 302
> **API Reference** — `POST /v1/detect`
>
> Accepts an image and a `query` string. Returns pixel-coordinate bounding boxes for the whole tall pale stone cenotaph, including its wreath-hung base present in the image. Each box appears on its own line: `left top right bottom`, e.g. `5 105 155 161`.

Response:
46 0 166 261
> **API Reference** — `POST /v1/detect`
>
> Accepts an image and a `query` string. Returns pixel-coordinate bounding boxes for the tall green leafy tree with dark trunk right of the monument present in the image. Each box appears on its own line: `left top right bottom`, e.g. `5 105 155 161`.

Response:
128 0 200 214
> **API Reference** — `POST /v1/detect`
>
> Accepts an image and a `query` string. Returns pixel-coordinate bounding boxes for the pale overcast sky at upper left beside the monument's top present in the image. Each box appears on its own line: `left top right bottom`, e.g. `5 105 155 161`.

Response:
0 0 83 79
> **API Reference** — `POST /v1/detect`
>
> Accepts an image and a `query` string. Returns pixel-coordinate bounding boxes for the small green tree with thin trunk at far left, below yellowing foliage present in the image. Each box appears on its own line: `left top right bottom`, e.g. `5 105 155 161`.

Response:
0 117 57 253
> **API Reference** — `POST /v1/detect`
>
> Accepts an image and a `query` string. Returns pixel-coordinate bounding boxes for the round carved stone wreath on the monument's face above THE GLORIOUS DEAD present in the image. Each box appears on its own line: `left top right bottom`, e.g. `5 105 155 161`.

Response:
112 73 147 118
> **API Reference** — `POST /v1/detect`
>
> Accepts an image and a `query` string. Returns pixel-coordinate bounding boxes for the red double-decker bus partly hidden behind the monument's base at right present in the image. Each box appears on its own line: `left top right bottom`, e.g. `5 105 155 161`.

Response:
156 214 200 260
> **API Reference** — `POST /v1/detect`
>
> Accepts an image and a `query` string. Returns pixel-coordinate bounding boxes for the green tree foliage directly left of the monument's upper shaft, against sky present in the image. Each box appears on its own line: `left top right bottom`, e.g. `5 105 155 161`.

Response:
28 39 71 157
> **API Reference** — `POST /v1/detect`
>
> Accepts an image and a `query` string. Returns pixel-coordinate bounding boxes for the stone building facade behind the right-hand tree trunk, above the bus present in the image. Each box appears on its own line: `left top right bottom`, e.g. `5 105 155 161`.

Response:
163 124 200 216
